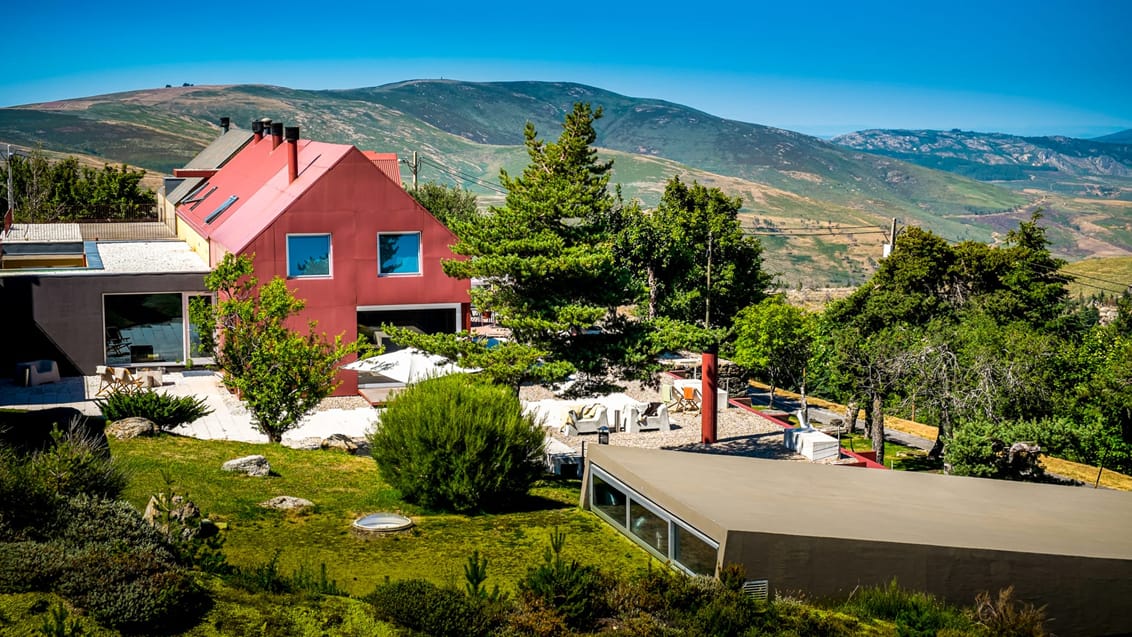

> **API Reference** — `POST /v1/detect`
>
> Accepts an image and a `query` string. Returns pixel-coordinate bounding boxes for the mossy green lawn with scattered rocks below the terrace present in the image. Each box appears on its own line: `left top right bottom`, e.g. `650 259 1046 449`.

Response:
112 436 650 594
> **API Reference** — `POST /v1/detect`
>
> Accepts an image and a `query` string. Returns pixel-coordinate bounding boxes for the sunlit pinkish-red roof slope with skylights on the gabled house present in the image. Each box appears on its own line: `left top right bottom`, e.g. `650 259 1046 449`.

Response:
177 137 353 252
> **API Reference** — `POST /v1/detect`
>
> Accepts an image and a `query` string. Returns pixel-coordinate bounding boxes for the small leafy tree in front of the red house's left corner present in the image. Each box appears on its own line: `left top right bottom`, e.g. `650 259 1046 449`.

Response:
189 253 366 442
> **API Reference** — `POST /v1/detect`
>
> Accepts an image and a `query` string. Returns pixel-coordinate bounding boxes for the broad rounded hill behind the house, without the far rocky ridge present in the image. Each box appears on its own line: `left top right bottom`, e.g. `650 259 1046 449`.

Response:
0 79 1132 285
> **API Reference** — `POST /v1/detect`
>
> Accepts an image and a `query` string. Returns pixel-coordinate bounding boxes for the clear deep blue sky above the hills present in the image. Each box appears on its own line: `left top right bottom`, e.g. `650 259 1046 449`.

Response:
0 0 1132 137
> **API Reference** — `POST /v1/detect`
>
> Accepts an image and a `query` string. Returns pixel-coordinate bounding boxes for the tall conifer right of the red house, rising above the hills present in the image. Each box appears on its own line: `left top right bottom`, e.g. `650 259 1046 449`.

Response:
444 104 641 386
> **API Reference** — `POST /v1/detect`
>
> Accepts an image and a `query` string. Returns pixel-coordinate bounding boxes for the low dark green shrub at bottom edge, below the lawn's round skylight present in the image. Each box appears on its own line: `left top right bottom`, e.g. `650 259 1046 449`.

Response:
366 579 497 637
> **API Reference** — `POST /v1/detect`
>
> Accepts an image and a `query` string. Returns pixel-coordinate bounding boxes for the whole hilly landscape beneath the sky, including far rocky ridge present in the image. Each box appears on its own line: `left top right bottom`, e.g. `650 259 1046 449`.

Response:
0 80 1132 287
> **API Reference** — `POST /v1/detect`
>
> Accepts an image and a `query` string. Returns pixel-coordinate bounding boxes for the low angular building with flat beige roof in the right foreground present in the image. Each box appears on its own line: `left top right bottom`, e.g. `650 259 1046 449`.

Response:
582 445 1132 636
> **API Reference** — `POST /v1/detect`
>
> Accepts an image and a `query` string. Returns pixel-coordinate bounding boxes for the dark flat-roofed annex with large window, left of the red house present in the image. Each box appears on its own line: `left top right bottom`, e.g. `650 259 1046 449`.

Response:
0 224 211 376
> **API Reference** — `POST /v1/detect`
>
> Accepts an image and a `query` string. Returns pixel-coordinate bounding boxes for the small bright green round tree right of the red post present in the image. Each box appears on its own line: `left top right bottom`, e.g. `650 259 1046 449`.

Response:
730 294 814 408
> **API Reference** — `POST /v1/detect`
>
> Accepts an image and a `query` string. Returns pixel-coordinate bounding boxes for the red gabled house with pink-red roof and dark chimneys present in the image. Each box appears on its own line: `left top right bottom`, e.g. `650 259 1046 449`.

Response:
170 122 470 395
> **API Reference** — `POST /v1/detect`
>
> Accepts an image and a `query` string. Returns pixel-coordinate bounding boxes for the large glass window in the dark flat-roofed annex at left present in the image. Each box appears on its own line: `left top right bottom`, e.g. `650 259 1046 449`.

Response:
103 292 186 365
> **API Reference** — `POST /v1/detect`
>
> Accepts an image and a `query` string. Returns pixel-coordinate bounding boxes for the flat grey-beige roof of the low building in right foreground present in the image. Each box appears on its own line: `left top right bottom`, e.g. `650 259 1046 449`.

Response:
586 445 1132 560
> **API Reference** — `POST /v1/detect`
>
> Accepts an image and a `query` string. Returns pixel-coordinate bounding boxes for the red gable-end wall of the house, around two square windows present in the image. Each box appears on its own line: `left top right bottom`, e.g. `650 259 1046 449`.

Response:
238 149 470 396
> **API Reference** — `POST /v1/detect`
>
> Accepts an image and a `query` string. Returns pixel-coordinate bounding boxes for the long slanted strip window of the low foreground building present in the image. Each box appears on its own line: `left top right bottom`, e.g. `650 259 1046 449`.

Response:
590 463 719 576
